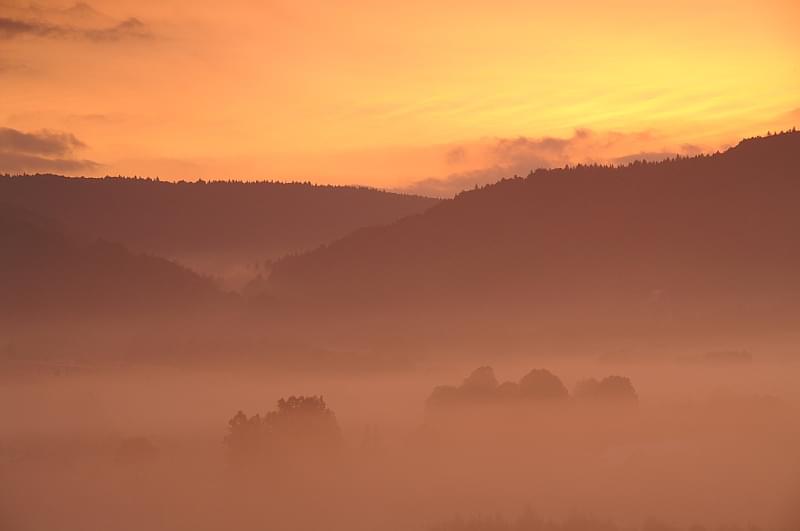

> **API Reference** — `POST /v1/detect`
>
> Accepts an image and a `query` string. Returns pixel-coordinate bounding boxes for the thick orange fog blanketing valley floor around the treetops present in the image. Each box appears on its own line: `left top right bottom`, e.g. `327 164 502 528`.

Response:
0 352 800 530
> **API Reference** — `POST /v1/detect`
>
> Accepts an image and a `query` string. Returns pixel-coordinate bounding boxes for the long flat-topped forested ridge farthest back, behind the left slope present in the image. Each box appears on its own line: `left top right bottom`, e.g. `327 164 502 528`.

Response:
0 176 438 286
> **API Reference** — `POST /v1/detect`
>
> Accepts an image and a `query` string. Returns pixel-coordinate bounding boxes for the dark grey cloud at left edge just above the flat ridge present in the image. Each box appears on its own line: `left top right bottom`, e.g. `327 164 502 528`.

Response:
0 127 100 173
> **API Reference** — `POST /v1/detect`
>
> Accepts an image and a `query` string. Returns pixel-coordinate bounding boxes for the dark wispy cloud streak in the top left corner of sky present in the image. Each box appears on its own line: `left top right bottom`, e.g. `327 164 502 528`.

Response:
0 2 152 42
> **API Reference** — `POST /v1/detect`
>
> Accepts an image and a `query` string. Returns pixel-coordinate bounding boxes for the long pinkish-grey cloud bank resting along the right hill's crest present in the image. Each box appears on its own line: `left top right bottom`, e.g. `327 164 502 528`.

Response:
402 129 704 197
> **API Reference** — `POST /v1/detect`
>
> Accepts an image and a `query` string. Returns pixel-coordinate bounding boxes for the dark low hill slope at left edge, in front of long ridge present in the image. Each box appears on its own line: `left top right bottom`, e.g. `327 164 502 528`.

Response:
0 203 222 326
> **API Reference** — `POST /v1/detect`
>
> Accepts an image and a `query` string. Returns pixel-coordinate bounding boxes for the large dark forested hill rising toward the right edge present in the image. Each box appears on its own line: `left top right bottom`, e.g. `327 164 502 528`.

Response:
270 132 800 348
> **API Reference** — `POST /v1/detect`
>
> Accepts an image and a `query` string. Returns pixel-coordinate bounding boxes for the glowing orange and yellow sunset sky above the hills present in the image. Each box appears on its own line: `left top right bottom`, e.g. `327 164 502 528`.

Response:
0 0 800 196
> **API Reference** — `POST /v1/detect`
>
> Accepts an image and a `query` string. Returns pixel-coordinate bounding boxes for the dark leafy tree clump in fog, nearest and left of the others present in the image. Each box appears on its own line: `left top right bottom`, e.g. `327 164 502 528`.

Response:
225 396 341 466
